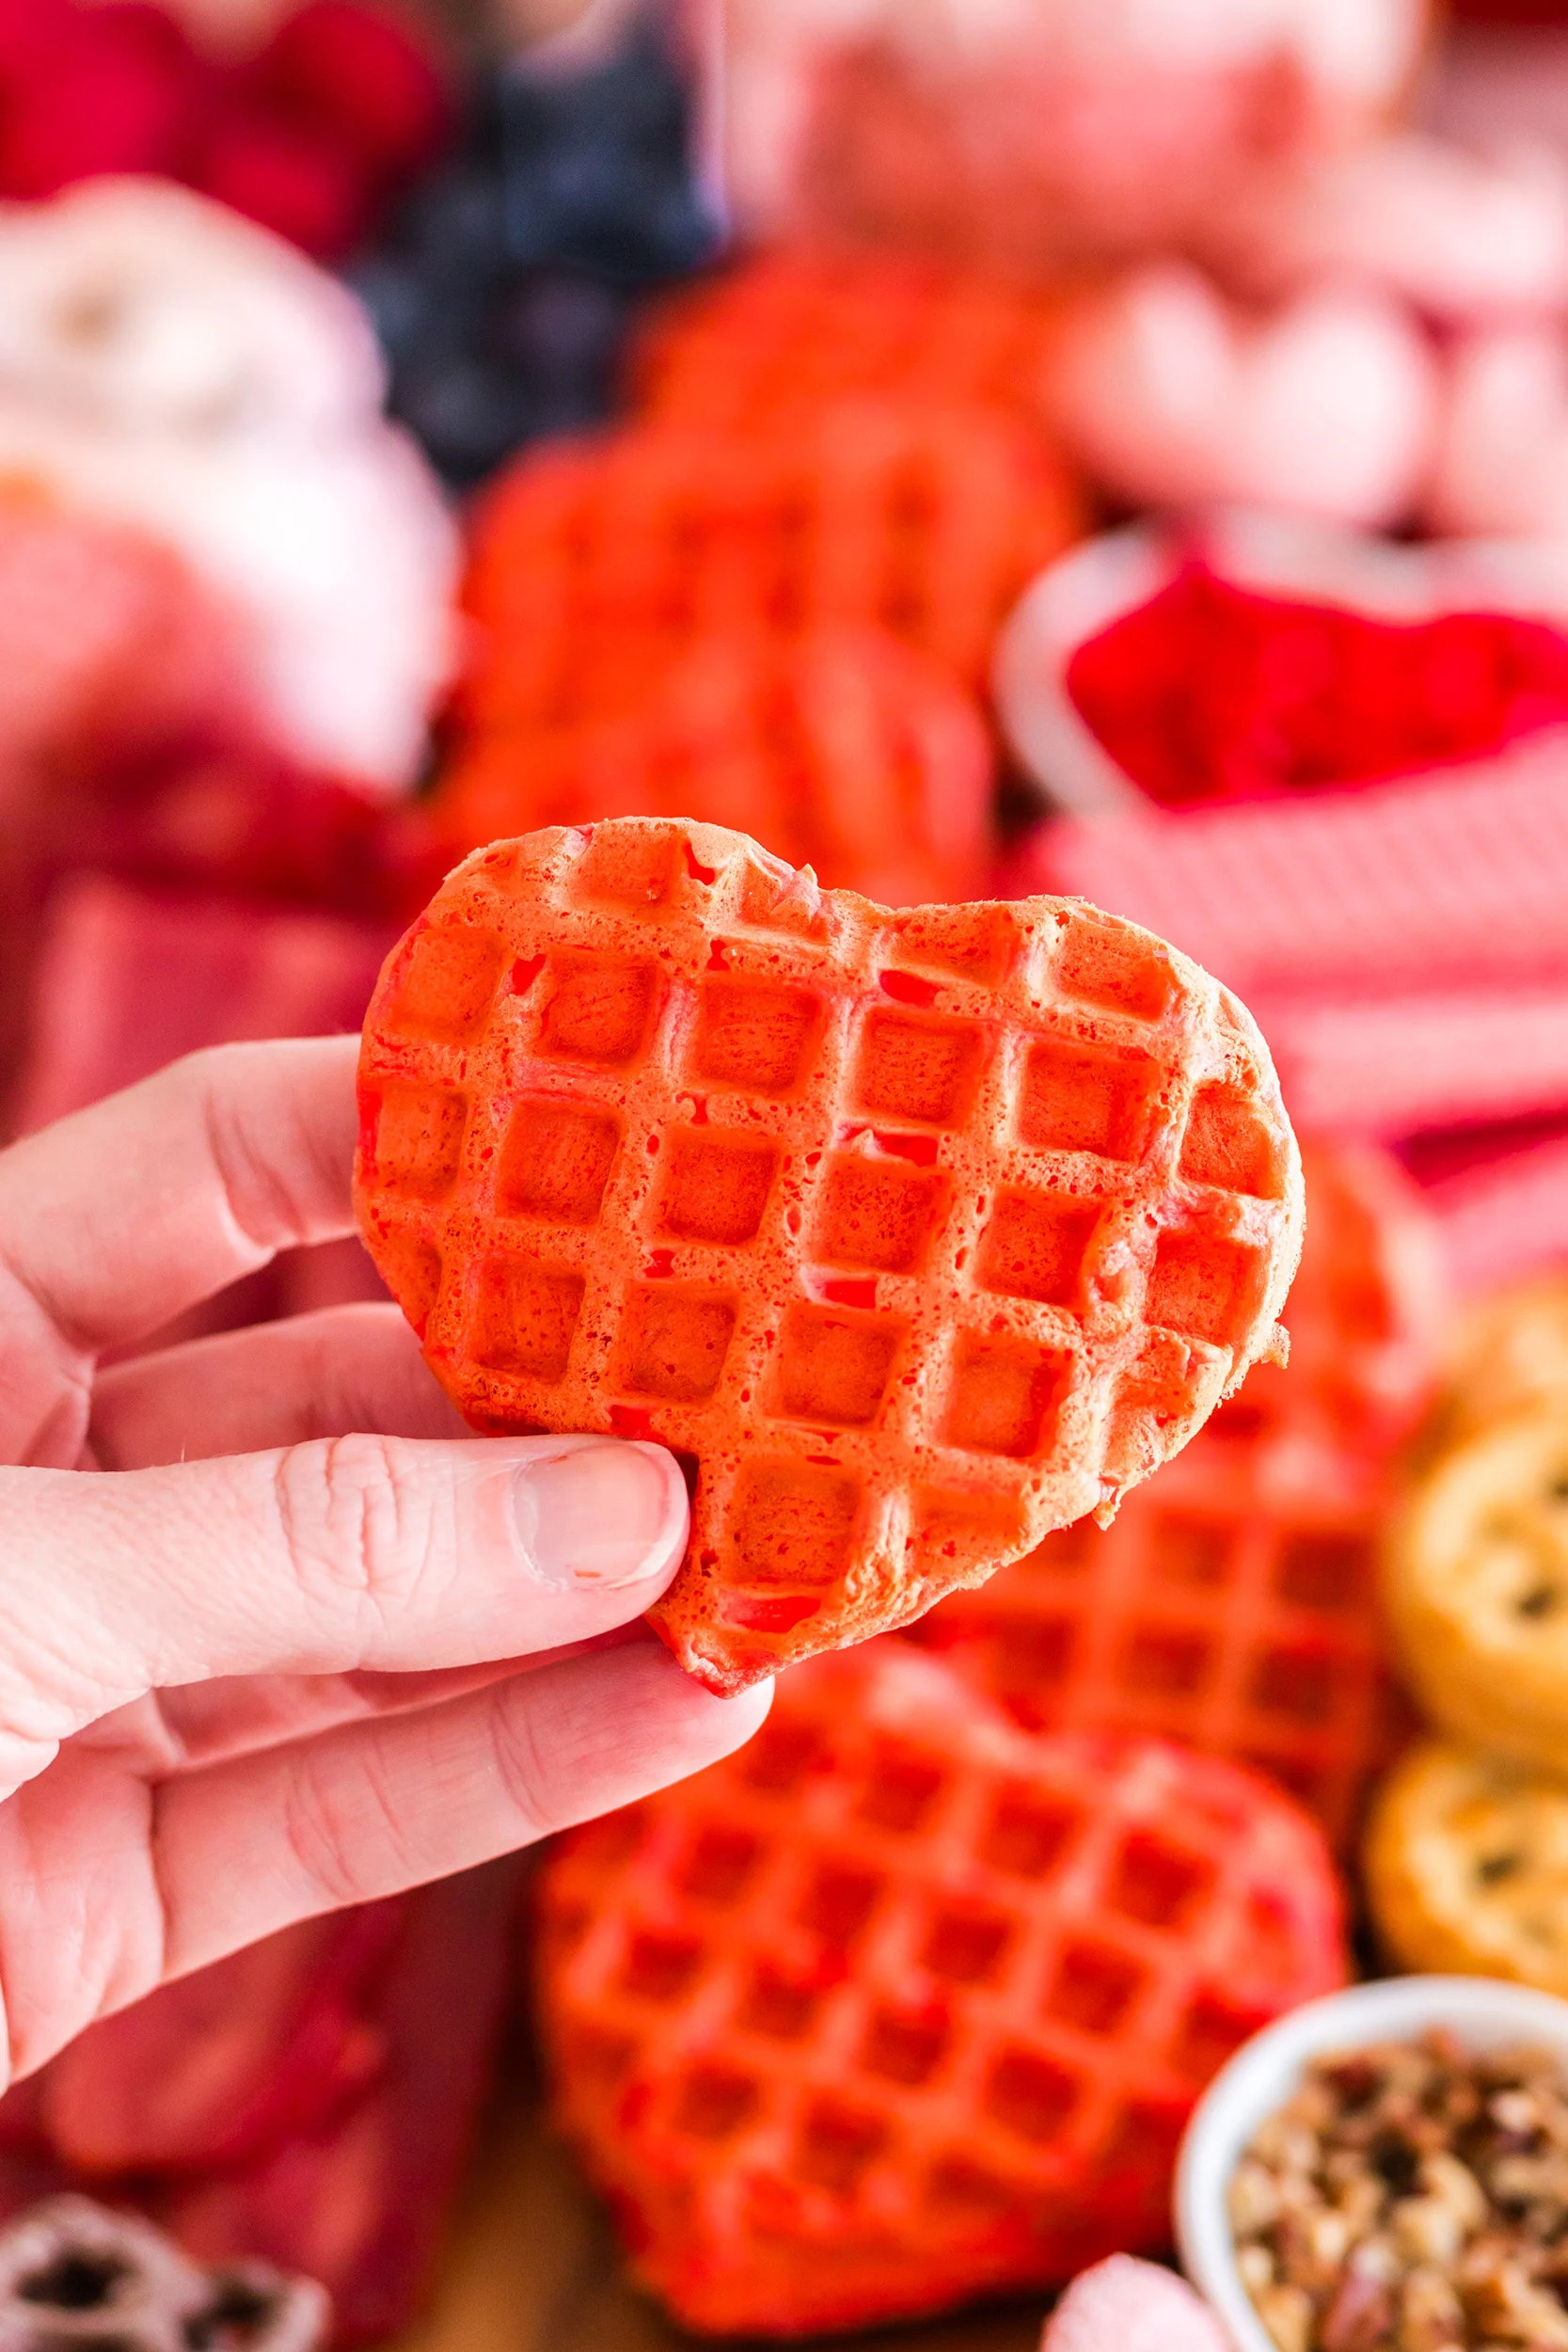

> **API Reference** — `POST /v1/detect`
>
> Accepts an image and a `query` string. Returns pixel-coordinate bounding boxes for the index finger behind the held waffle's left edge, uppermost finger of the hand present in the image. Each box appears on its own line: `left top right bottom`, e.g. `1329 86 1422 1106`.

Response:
0 1038 359 1355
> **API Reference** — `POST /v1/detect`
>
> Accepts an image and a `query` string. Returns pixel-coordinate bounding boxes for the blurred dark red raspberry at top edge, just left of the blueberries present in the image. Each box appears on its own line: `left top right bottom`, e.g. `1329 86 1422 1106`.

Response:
256 0 451 174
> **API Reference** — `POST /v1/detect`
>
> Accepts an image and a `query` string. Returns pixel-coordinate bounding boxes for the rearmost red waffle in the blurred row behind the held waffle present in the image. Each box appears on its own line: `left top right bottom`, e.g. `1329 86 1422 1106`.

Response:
630 249 1060 433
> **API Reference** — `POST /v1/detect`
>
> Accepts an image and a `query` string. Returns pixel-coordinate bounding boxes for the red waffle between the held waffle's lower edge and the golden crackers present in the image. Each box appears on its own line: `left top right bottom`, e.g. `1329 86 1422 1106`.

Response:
917 1430 1411 1847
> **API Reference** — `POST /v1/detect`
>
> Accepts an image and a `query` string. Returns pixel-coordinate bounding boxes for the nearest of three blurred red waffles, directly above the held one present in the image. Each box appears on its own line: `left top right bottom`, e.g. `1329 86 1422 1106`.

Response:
433 628 992 906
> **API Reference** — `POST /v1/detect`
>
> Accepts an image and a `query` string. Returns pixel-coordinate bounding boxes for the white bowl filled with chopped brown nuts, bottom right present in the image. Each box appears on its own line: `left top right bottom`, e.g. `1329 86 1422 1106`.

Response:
1176 1976 1568 2352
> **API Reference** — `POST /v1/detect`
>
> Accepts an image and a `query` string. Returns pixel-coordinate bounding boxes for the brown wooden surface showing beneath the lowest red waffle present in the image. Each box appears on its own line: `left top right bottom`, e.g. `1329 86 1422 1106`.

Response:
397 2063 1044 2352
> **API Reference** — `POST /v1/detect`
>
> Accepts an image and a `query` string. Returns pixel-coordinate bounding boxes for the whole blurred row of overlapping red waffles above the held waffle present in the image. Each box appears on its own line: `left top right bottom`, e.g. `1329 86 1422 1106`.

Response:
437 259 1079 906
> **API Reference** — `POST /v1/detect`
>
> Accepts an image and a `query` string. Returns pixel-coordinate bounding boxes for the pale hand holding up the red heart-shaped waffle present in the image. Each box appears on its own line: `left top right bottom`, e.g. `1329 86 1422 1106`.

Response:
0 1038 768 2089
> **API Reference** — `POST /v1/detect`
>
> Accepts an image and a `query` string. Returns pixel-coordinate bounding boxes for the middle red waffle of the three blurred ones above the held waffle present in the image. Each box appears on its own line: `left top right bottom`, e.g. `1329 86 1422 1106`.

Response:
461 400 1079 724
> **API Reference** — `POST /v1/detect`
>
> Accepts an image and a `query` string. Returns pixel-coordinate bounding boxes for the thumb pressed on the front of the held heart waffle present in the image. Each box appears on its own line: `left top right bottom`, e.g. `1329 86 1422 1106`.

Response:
0 1438 687 1790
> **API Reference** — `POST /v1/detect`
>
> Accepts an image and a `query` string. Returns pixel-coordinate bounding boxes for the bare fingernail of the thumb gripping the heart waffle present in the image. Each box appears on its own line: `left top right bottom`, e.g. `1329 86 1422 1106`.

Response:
513 1439 687 1593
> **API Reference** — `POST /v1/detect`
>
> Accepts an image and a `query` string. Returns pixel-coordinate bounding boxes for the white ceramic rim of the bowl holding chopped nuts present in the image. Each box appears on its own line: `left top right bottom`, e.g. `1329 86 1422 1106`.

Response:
1176 1976 1568 2352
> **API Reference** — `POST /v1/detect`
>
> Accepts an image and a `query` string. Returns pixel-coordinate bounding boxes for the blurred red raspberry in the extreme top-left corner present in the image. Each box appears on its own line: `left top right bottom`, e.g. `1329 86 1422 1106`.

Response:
0 5 198 198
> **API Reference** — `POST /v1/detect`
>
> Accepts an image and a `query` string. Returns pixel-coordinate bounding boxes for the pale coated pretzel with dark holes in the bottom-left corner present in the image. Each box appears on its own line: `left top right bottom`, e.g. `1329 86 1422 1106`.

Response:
0 2197 331 2352
